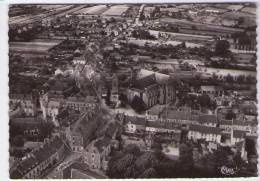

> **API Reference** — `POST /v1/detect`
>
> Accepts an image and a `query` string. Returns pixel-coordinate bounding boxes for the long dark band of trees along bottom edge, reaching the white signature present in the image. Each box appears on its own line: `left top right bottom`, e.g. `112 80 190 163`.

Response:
107 134 252 178
